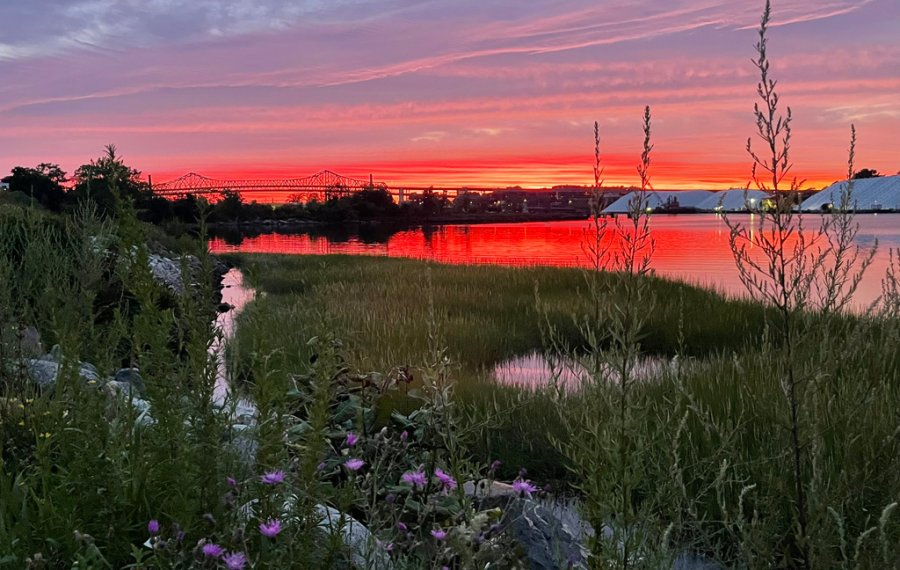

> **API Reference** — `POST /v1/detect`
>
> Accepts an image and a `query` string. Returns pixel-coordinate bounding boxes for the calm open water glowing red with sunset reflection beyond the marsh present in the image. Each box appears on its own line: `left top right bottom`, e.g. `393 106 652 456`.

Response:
210 214 900 305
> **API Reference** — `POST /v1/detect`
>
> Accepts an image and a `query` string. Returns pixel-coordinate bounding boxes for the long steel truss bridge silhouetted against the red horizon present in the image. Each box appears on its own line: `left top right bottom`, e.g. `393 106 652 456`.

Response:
151 170 506 202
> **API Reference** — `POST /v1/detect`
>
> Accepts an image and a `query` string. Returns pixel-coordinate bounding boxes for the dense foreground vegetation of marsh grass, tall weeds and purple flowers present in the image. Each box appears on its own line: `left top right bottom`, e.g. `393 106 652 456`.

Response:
0 2 900 570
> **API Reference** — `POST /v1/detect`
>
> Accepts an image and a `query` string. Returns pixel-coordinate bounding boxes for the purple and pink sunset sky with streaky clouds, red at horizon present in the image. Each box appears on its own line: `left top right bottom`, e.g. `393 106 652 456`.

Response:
0 0 900 188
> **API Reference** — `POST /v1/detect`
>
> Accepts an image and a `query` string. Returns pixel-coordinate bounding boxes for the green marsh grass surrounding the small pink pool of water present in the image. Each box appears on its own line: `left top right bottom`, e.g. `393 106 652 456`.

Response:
225 256 900 567
